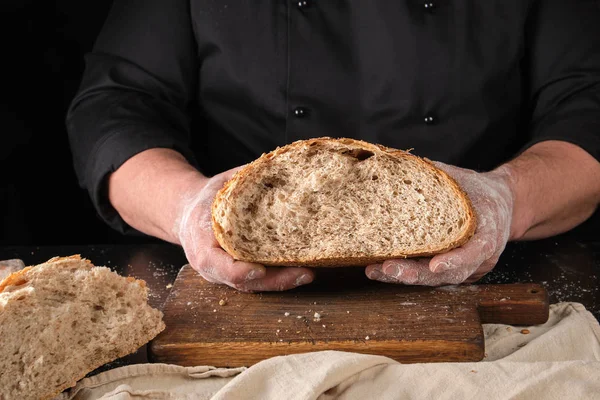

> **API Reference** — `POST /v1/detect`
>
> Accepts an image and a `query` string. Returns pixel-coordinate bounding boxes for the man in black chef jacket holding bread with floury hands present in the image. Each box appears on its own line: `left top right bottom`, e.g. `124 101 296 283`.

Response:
66 0 600 290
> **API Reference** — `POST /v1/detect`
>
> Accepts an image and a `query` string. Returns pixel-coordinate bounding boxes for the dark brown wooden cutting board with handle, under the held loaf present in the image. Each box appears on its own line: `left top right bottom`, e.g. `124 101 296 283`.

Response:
149 265 549 367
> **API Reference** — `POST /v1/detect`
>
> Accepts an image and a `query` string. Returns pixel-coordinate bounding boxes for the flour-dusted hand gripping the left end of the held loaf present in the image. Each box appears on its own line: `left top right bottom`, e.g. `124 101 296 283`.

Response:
174 168 314 292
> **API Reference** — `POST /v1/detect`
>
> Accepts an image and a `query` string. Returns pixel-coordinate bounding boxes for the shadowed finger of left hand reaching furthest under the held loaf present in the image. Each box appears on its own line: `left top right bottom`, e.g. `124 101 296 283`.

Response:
235 267 314 292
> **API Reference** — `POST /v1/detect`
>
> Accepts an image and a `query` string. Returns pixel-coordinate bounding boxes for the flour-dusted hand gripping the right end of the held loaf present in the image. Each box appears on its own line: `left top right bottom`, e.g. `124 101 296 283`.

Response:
366 162 513 286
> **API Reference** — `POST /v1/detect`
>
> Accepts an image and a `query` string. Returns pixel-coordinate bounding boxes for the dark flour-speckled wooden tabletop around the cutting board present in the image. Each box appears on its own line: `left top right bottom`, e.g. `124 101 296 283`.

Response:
0 225 600 374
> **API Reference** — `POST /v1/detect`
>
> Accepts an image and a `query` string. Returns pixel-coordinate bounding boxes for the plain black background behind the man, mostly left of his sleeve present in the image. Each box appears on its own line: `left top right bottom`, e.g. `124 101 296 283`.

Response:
0 0 600 245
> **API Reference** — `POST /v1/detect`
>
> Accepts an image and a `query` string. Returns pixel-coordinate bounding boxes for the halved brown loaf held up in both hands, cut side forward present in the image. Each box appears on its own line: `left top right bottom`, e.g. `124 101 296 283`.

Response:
212 137 475 267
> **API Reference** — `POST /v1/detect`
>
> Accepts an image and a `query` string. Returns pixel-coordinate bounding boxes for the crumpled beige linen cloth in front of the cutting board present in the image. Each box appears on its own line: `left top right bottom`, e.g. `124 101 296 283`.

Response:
57 302 600 400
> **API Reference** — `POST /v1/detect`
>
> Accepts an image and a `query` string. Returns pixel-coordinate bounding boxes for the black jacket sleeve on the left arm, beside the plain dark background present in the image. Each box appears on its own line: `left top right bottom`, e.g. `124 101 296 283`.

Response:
66 0 197 233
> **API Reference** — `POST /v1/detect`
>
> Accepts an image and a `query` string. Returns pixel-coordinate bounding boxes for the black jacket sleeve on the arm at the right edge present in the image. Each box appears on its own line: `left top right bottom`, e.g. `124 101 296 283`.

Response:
522 0 600 161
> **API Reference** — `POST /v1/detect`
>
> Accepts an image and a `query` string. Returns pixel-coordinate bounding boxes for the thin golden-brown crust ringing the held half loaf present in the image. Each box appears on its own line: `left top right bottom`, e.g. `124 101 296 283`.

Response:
211 136 477 267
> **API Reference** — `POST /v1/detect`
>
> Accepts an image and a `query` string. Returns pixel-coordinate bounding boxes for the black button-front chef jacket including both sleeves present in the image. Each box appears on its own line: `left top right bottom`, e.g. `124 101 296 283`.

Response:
66 0 600 231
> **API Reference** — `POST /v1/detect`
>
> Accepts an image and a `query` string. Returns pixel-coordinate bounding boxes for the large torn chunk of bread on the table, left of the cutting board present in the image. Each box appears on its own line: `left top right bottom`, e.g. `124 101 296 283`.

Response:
0 255 165 400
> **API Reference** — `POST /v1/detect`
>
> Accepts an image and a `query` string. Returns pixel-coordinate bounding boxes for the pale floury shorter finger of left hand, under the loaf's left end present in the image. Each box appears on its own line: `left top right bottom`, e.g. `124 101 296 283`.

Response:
194 248 266 286
